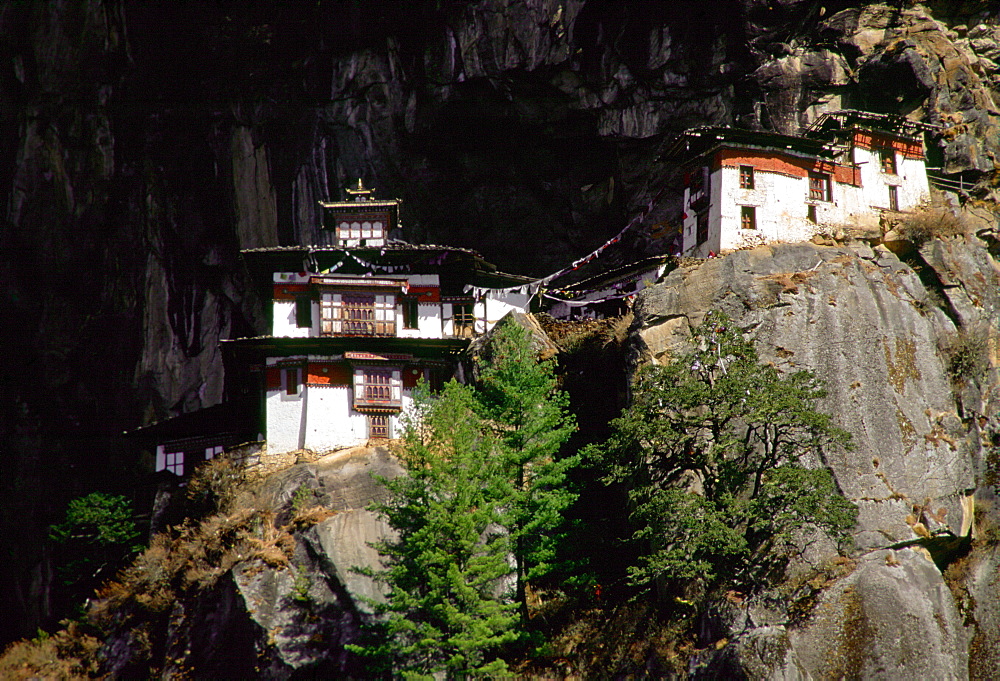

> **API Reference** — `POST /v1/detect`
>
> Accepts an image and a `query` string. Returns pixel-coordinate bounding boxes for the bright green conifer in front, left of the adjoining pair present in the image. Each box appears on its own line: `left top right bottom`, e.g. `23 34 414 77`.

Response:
353 382 518 678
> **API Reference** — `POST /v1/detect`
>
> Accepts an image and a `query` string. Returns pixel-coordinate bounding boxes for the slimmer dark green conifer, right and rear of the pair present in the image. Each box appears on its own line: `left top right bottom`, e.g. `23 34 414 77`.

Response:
475 321 580 616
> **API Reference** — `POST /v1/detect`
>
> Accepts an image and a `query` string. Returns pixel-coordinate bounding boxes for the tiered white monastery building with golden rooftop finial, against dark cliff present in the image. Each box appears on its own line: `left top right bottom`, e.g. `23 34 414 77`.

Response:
142 181 531 475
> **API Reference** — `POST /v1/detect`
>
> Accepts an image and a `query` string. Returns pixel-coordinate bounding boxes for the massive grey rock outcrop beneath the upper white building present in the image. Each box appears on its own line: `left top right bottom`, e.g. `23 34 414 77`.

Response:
633 232 1000 678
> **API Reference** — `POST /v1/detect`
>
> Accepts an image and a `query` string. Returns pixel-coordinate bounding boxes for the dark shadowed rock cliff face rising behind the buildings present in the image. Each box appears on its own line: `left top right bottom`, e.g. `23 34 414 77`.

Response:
0 0 1000 639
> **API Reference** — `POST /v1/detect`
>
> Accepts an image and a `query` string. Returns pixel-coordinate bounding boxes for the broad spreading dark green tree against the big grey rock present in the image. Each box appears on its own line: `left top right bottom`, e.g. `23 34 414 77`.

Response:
602 312 857 586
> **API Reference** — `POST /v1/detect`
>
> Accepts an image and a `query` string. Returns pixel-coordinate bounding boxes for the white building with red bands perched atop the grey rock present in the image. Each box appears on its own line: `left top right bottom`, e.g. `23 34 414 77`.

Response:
667 111 933 257
